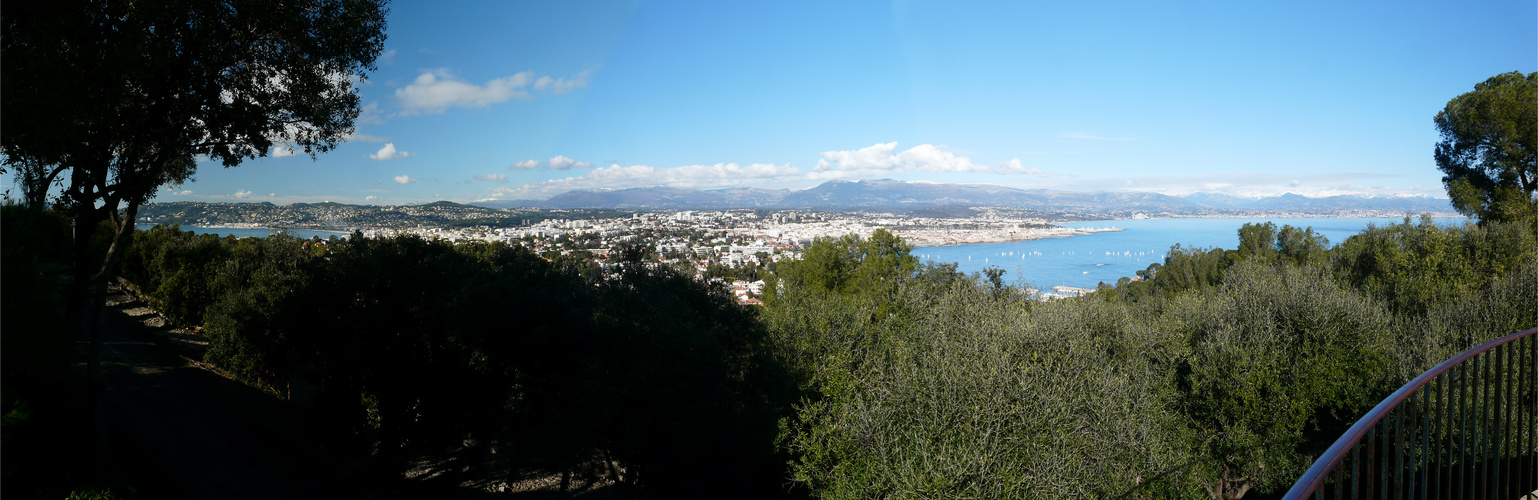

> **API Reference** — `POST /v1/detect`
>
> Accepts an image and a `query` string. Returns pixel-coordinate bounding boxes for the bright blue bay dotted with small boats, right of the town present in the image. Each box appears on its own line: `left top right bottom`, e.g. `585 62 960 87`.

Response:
914 217 1466 291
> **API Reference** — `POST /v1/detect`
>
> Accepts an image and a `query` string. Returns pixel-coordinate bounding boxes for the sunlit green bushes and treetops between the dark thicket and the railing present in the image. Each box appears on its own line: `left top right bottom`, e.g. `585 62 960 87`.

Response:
763 215 1538 498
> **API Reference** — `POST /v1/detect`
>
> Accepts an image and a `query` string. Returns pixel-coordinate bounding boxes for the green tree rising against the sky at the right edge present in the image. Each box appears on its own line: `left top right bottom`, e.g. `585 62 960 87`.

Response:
1435 71 1538 220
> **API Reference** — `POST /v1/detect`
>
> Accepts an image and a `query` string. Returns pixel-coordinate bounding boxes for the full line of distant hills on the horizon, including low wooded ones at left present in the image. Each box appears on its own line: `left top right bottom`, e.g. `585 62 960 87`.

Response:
138 178 1453 229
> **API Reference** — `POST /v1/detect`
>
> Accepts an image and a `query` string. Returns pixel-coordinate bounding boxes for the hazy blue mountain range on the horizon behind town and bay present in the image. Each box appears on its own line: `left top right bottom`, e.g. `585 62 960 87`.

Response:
474 178 1453 215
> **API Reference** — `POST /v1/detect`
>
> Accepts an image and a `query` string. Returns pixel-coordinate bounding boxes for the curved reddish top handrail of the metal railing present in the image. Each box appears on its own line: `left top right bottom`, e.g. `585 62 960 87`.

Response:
1283 328 1538 500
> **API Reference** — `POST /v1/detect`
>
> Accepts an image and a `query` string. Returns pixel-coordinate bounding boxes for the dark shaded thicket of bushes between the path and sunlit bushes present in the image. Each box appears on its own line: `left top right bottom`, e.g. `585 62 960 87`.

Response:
129 228 794 497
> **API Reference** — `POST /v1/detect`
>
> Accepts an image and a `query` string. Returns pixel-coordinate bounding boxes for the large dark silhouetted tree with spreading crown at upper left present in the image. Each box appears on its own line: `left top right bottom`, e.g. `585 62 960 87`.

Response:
0 0 386 468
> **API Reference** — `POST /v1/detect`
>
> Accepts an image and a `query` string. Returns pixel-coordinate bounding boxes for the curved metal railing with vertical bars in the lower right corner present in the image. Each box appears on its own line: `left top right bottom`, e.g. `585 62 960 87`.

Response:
1284 328 1538 500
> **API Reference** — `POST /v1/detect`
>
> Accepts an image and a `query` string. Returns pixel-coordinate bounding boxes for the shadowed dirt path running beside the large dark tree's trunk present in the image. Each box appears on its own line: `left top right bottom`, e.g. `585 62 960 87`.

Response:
91 293 343 498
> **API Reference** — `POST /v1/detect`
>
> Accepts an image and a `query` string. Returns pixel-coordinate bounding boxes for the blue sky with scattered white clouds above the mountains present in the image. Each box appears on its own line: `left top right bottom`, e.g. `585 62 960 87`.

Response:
138 0 1538 205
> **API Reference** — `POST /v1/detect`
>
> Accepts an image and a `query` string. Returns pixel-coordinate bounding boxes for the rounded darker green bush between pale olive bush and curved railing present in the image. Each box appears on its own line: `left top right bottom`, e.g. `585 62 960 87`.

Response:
1170 263 1393 489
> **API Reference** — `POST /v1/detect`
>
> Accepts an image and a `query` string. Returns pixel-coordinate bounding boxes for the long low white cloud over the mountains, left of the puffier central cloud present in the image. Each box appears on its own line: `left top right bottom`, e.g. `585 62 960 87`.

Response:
492 163 801 197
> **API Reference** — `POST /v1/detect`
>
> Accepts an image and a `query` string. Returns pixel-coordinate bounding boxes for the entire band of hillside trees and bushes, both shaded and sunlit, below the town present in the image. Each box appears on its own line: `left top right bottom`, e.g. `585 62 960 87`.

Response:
8 209 1538 498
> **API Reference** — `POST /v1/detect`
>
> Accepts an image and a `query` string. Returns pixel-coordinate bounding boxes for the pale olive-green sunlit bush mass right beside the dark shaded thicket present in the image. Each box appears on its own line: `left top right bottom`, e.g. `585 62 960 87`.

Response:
764 236 1184 498
